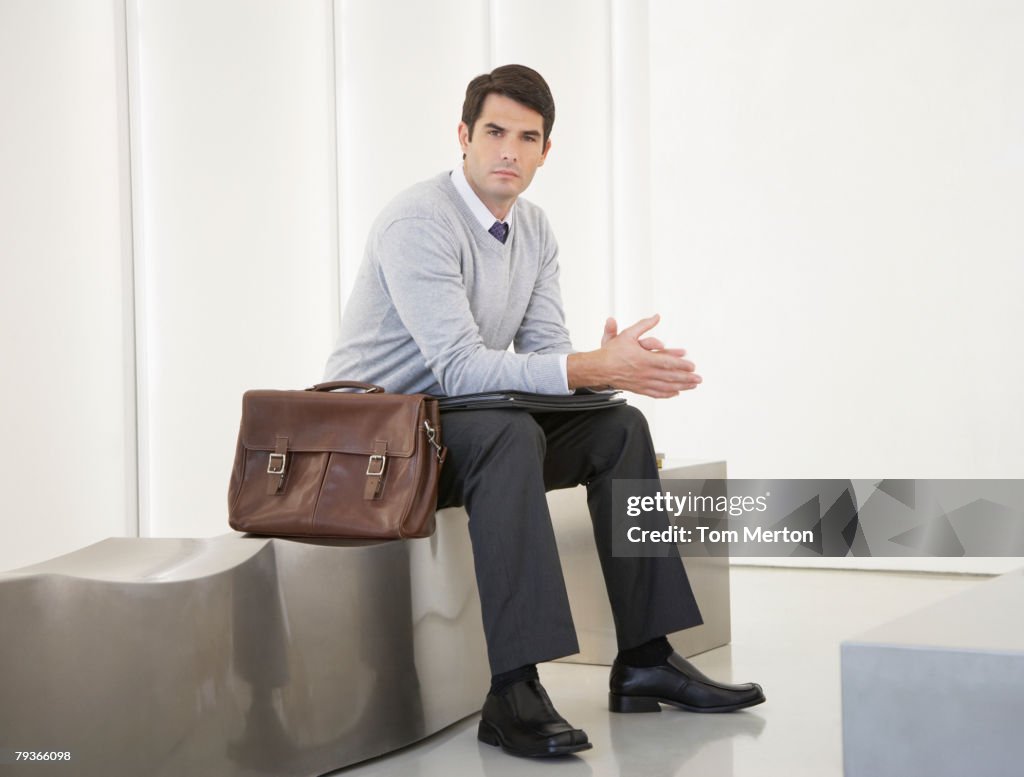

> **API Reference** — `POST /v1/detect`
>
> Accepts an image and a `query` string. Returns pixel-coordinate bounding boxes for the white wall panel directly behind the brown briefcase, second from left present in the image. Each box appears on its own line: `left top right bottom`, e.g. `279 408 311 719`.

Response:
131 0 337 536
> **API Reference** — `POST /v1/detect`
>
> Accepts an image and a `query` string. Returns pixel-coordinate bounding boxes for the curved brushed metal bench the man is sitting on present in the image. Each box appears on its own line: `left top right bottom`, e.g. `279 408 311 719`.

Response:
0 463 729 777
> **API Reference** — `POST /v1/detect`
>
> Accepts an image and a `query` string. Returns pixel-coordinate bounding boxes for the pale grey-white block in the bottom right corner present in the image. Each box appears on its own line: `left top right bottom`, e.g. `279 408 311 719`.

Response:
841 572 1024 777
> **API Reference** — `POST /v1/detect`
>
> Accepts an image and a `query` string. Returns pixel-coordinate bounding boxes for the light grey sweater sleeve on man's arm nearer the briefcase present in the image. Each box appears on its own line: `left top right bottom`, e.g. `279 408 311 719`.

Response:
376 218 565 396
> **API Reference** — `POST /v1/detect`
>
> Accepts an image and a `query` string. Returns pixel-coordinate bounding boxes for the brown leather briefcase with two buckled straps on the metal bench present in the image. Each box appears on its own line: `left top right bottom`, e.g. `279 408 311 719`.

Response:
227 381 445 539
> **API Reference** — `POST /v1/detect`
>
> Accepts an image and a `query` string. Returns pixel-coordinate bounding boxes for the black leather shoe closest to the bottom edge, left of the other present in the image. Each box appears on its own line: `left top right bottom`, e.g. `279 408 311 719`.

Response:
476 680 593 758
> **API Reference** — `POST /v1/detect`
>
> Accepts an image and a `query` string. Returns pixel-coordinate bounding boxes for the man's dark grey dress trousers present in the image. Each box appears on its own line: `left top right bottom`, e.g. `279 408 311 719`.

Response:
437 405 702 674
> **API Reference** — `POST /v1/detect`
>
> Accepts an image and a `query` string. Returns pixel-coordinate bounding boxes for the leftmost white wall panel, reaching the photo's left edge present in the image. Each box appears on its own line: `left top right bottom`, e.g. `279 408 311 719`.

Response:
0 0 135 569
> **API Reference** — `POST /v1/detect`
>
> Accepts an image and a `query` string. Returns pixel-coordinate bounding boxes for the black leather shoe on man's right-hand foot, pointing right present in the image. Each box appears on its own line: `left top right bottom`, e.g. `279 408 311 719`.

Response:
608 653 765 713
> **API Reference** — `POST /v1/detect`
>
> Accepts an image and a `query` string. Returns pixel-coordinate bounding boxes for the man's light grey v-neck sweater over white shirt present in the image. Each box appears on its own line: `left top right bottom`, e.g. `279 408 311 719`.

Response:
325 172 572 395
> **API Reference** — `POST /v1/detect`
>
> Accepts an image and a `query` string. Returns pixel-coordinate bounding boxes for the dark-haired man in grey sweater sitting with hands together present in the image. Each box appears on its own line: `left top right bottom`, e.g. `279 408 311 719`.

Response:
326 66 765 756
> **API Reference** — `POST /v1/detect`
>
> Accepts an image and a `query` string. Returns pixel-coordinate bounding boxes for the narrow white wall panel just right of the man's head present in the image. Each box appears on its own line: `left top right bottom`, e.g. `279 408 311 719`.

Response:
490 0 612 350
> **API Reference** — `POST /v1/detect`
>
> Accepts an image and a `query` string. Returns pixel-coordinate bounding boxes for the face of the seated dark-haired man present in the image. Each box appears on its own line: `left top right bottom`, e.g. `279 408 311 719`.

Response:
459 94 551 220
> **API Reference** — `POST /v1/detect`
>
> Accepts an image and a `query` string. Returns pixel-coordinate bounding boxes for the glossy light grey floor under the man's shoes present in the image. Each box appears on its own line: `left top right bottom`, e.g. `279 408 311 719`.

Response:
334 567 985 777
